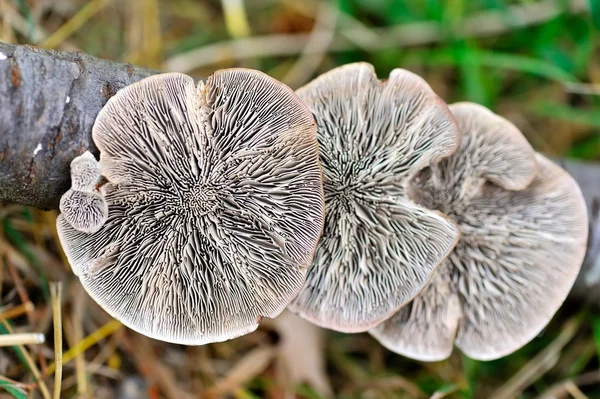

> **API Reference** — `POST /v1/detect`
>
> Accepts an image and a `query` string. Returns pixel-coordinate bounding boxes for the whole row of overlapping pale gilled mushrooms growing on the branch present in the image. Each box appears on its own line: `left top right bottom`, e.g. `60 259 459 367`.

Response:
57 63 588 361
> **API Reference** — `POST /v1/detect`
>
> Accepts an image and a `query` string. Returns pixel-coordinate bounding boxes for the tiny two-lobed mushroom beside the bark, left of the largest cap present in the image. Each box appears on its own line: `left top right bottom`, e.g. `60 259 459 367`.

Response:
59 151 108 233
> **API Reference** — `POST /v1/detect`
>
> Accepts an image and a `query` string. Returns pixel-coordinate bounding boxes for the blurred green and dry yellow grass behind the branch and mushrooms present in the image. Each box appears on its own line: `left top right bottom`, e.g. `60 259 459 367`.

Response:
0 0 600 399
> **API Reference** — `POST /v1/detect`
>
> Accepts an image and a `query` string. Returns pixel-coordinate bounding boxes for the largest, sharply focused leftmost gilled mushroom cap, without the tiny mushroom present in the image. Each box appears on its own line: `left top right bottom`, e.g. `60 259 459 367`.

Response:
58 69 324 345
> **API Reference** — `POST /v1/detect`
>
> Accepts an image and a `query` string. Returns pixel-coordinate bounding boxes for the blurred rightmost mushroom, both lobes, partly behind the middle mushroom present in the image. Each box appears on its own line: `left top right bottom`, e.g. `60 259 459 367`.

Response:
370 103 588 361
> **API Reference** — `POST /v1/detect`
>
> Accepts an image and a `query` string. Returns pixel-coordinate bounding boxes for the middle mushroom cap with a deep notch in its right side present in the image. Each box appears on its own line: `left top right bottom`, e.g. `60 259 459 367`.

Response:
288 63 459 332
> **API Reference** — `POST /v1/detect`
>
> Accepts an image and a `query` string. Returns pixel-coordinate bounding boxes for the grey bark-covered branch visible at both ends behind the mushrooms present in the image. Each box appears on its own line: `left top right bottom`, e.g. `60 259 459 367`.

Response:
0 42 600 304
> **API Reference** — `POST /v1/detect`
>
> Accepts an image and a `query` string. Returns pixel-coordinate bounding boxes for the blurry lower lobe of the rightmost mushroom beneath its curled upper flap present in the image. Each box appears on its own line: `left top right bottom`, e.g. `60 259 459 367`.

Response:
371 154 587 360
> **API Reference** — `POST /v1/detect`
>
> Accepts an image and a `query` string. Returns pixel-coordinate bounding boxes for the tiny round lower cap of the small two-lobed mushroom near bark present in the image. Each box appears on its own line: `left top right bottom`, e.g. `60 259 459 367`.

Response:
59 189 108 234
